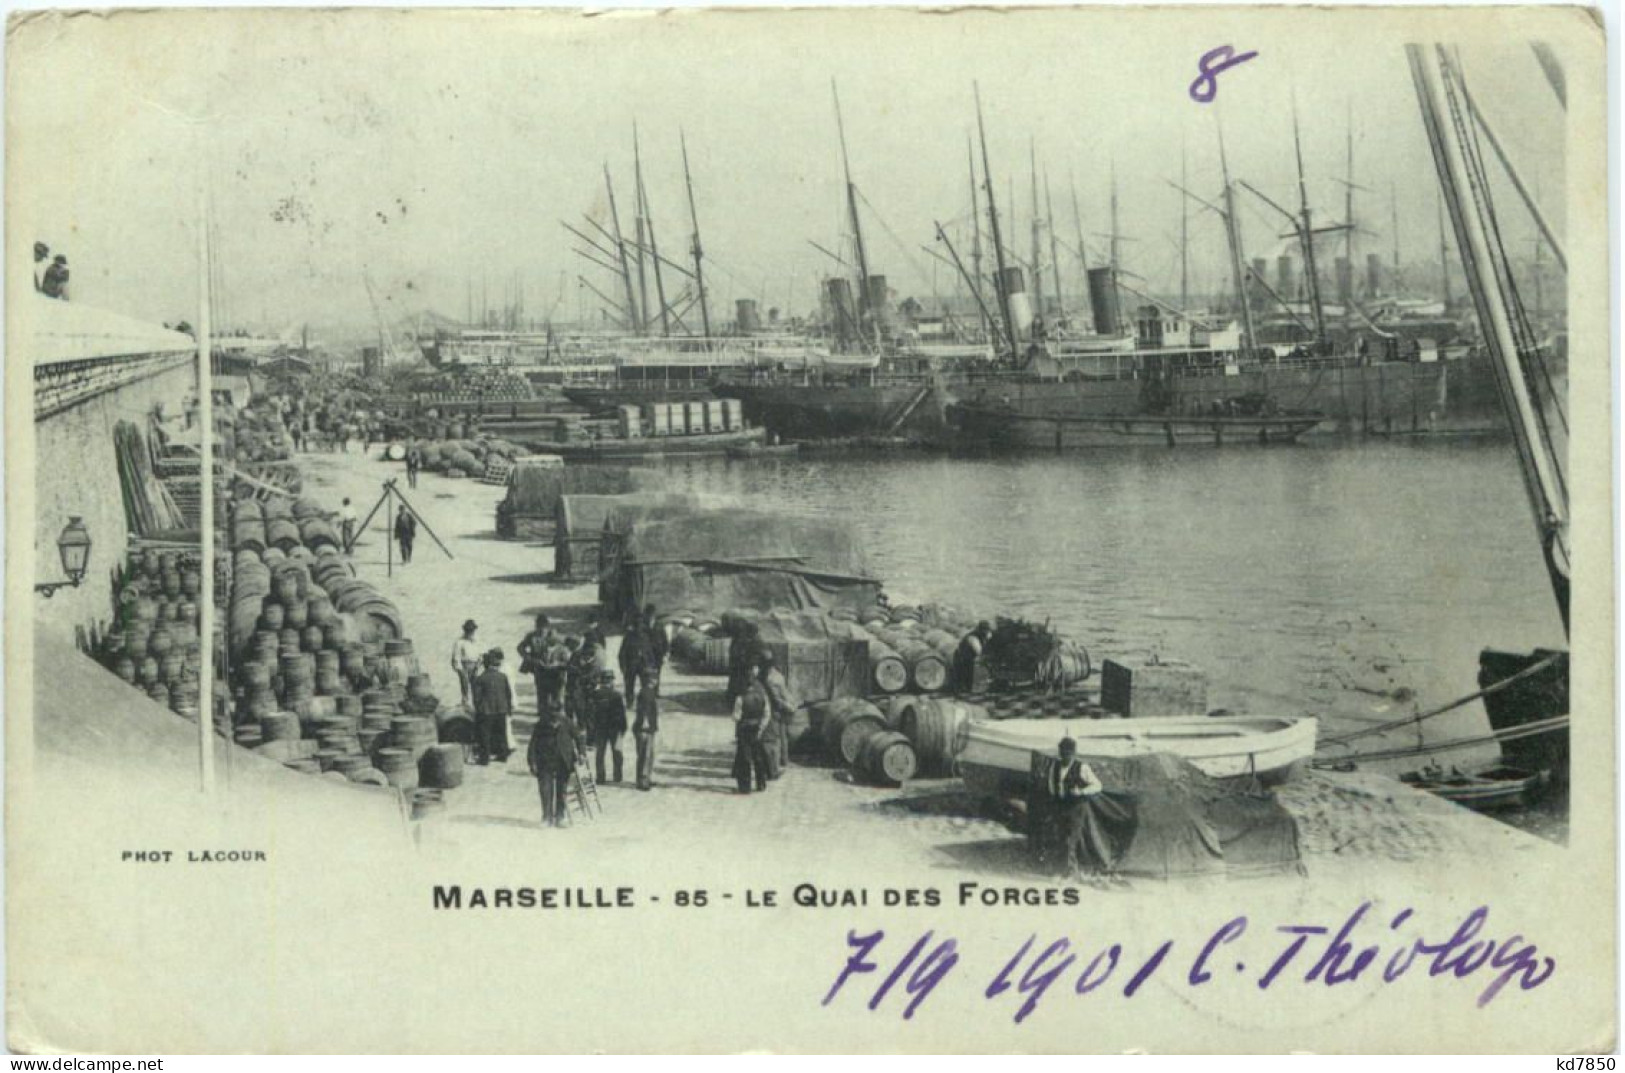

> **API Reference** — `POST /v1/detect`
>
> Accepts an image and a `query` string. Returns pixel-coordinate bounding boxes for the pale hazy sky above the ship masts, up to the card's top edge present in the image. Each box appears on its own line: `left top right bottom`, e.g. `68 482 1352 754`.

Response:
7 8 1579 339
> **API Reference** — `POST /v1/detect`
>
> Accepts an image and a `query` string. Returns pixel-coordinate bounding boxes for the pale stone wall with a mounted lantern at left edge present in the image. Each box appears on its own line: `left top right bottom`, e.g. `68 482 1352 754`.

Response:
31 358 197 637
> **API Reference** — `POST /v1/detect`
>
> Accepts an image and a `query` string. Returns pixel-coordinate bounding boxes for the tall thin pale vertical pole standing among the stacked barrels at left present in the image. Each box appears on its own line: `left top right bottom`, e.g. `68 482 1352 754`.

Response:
197 144 215 795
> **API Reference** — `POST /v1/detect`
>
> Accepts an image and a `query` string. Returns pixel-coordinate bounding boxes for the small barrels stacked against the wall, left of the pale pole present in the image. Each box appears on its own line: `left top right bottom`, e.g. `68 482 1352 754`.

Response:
98 550 203 719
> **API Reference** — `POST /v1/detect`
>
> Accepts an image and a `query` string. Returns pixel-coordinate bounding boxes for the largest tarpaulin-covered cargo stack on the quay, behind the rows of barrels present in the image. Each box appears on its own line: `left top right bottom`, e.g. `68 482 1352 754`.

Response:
600 507 879 615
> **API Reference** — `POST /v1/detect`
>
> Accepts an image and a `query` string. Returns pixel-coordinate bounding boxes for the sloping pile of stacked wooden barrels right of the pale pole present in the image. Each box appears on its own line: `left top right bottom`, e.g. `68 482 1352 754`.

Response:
226 487 462 792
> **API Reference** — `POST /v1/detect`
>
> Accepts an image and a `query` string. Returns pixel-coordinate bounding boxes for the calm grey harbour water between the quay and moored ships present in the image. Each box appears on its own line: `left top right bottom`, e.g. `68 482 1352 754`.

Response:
666 439 1565 836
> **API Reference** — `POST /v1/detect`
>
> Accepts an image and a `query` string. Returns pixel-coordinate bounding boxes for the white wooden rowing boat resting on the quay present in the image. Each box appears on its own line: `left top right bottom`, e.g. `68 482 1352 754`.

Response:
957 715 1318 797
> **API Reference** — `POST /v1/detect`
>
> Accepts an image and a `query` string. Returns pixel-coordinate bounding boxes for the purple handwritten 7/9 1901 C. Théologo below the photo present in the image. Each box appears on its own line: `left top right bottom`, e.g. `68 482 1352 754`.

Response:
824 902 1557 1024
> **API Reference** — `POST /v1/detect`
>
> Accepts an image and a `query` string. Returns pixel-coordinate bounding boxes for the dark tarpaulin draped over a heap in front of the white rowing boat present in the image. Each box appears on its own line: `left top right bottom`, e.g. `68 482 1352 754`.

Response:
1032 753 1302 880
